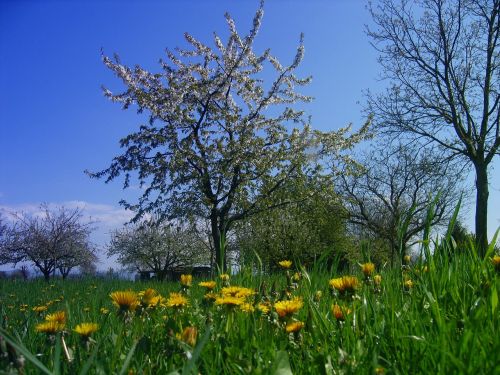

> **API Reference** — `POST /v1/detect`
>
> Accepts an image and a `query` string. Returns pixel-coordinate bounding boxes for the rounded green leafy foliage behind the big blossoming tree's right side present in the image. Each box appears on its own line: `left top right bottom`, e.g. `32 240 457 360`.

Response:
235 179 352 271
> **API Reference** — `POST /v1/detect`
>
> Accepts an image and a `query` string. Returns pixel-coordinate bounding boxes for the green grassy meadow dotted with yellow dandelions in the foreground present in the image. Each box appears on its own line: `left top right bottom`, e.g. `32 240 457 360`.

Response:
0 248 500 374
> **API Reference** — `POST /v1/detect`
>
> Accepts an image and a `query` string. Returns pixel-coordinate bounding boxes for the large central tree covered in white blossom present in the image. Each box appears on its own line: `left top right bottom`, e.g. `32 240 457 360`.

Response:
89 4 366 271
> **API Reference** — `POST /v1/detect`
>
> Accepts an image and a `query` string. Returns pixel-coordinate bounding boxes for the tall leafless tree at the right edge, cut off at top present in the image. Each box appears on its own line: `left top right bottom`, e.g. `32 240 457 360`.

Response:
368 0 500 254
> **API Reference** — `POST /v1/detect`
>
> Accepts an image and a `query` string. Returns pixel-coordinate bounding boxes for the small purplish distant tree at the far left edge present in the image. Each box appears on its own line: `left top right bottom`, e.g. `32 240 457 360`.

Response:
0 205 95 280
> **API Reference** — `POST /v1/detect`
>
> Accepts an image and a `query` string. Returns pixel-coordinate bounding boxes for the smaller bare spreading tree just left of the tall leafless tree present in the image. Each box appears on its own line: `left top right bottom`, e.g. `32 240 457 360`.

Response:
338 145 461 264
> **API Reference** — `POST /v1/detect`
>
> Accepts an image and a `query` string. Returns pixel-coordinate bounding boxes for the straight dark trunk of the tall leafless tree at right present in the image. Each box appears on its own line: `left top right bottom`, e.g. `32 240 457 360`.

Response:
474 163 489 257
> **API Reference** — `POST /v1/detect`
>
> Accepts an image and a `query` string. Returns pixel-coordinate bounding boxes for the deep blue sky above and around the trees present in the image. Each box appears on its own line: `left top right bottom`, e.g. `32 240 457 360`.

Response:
0 0 500 270
